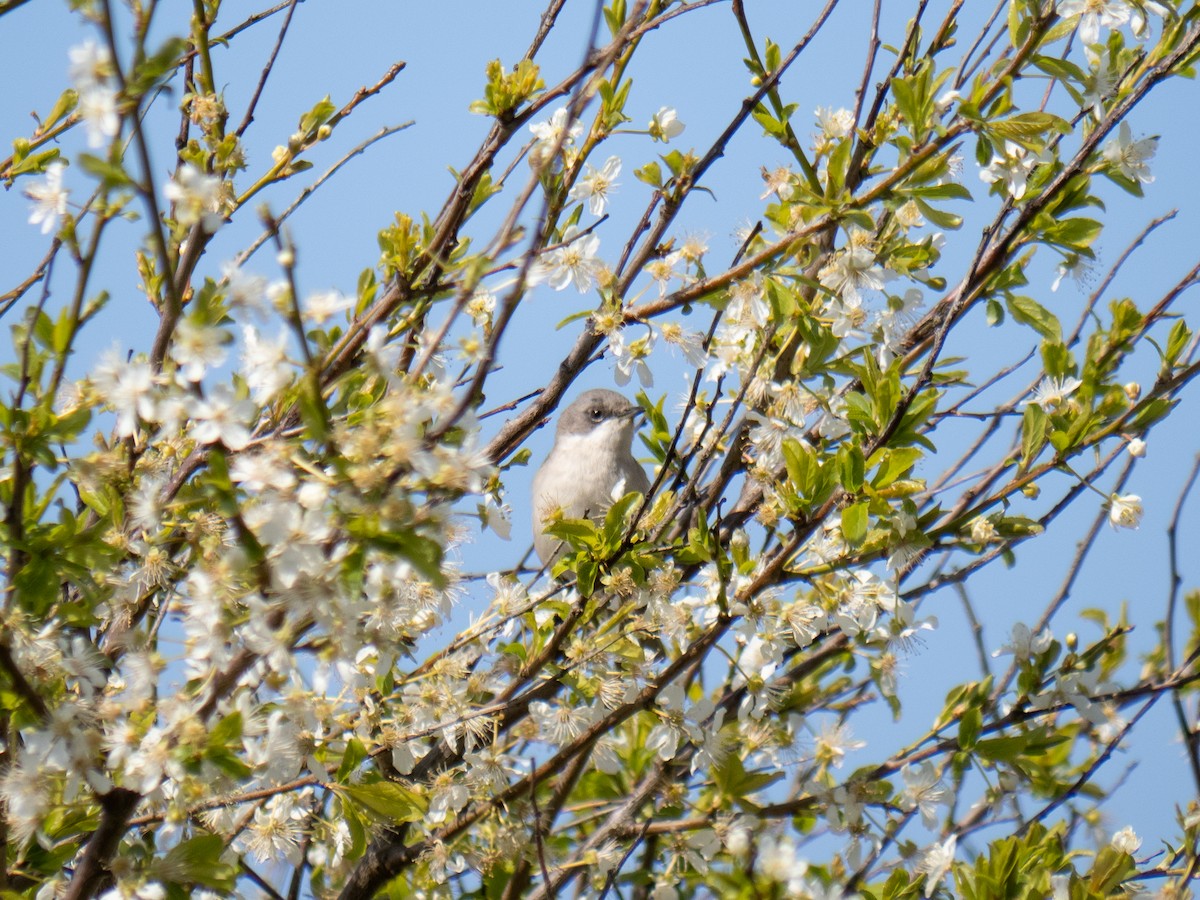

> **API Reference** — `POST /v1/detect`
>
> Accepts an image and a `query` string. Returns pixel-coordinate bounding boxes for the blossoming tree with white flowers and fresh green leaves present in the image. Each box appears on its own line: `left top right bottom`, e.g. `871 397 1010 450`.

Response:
0 0 1200 899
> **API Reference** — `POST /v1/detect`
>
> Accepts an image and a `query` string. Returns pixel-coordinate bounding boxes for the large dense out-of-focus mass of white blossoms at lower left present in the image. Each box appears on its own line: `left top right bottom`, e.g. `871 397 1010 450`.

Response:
10 244 506 868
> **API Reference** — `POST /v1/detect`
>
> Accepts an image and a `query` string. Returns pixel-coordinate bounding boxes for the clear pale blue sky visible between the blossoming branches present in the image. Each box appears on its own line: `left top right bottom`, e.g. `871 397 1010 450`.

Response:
0 0 1200 873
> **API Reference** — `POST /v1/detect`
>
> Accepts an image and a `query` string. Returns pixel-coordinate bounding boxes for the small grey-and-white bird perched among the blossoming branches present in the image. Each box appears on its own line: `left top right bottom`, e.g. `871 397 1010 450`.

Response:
533 389 650 564
